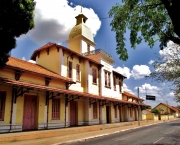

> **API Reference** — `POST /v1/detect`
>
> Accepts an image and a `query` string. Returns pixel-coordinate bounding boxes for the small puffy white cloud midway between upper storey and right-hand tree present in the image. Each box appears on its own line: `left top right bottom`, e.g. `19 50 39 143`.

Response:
131 65 151 80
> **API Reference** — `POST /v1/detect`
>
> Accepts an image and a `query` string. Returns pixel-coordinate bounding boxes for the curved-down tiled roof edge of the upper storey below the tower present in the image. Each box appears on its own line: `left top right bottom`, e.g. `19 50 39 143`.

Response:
31 42 103 66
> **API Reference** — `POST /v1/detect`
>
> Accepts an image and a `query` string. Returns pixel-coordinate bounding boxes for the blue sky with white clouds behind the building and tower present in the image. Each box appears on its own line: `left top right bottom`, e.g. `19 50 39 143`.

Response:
11 0 177 107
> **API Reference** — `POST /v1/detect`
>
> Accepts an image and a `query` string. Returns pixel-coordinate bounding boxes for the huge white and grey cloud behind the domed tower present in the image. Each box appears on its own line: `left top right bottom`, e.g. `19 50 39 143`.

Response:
20 0 101 45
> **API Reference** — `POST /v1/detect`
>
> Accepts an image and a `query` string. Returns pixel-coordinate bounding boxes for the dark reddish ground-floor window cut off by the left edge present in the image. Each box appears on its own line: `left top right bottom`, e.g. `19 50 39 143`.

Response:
0 92 6 121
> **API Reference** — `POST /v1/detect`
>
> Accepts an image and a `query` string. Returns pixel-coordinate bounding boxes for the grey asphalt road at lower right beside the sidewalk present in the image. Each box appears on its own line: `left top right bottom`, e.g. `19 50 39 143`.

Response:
69 120 180 145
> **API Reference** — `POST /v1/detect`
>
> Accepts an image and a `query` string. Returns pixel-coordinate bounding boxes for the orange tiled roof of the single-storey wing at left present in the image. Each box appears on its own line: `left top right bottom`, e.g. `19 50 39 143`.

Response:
6 57 73 82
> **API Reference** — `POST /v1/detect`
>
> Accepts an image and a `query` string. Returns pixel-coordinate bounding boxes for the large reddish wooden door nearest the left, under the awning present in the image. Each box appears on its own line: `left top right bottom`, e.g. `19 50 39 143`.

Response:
23 95 37 130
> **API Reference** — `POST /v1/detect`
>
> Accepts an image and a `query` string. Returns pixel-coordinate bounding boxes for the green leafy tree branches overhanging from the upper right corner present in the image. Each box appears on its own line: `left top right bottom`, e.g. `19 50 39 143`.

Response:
109 0 180 61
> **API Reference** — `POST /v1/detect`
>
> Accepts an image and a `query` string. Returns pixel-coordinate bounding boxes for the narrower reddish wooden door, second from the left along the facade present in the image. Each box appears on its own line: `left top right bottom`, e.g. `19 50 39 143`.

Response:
70 101 76 126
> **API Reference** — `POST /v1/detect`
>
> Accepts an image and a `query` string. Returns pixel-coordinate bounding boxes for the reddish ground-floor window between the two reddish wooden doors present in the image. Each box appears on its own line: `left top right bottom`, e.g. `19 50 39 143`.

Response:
52 98 60 120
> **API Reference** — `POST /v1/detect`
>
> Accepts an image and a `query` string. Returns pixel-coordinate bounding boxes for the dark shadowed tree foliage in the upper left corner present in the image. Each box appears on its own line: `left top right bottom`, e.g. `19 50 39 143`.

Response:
0 0 35 67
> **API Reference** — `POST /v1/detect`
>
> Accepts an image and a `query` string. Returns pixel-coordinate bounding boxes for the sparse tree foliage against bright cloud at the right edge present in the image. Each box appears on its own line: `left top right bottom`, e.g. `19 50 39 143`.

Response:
149 43 180 102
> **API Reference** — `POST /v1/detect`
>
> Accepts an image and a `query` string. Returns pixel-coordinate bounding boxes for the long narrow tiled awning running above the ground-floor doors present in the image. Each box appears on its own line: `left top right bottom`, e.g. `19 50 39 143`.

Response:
0 77 148 106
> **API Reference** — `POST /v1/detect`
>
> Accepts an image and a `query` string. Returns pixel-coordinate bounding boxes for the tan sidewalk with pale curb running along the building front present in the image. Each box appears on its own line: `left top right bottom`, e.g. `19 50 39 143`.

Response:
0 119 179 145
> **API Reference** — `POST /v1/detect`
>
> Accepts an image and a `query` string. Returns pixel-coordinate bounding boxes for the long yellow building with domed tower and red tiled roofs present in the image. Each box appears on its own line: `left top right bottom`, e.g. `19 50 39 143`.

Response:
0 14 148 132
